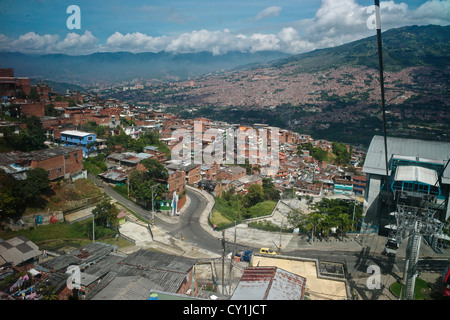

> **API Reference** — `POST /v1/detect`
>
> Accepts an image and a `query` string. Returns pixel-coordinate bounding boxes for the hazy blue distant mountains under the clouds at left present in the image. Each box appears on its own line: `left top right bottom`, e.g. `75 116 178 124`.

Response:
0 51 289 84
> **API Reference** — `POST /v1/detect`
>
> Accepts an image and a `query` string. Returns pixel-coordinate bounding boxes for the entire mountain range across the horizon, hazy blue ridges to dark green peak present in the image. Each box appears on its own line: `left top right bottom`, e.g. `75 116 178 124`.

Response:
0 25 450 85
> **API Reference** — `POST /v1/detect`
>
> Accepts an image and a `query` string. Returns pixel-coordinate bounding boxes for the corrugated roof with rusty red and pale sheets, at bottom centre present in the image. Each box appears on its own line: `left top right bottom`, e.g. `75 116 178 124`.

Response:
231 267 306 300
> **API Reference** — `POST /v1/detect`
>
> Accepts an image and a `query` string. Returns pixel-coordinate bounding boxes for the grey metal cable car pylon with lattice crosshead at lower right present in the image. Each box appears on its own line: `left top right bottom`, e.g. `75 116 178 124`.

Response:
391 204 444 300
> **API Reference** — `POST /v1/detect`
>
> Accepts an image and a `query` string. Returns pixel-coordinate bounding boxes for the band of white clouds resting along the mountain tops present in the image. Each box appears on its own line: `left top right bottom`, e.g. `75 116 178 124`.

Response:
0 0 450 55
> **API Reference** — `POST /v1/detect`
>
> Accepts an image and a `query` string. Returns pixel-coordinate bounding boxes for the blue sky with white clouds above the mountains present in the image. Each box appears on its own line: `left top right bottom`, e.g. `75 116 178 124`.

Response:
0 0 450 55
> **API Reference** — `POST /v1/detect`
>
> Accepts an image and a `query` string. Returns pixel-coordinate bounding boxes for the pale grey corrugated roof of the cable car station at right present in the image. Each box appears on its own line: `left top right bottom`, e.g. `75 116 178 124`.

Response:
363 136 450 184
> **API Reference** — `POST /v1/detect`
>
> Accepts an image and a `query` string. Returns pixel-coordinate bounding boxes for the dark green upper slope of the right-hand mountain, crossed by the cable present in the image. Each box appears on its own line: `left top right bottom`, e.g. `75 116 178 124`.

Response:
271 25 450 72
